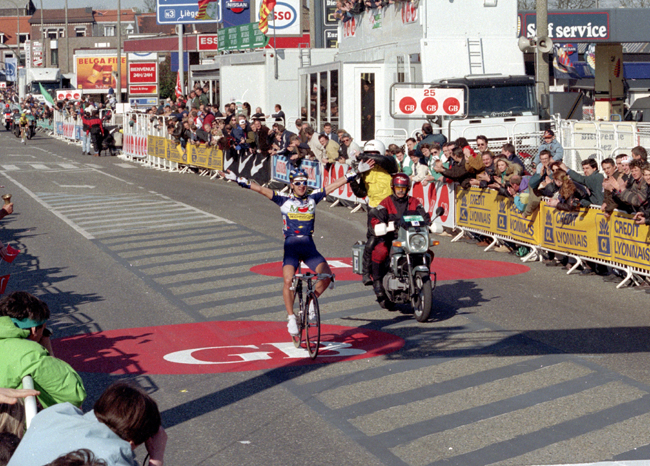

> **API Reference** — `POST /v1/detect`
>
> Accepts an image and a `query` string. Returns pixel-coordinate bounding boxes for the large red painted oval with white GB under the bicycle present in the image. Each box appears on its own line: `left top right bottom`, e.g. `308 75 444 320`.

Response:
54 321 404 374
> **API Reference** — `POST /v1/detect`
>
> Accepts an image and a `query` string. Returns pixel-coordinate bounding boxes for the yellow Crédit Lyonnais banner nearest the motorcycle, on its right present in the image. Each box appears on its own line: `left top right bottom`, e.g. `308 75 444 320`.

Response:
456 188 541 245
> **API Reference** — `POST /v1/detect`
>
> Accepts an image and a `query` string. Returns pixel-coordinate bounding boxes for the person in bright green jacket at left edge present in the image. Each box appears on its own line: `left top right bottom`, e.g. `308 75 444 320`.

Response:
0 291 86 408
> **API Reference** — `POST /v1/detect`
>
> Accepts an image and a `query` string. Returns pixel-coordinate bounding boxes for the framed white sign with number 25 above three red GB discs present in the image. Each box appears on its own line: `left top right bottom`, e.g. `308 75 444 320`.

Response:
390 83 467 120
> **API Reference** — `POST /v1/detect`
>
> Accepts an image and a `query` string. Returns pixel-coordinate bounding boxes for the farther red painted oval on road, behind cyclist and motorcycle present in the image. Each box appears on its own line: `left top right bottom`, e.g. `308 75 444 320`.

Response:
251 257 530 281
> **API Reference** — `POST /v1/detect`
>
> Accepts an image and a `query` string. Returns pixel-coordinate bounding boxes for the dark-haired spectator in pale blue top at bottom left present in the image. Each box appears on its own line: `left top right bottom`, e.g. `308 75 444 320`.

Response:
9 382 167 466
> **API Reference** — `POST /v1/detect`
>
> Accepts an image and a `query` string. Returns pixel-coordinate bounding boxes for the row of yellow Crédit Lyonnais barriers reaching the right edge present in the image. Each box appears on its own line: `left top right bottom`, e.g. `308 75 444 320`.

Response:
456 187 650 287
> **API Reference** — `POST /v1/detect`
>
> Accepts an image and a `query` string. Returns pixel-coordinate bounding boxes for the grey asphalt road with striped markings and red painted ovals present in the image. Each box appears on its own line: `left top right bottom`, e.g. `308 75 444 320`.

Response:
0 128 650 466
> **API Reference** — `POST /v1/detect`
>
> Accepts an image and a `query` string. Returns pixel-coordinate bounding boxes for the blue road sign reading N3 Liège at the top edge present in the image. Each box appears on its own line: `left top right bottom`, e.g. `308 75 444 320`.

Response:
156 0 222 24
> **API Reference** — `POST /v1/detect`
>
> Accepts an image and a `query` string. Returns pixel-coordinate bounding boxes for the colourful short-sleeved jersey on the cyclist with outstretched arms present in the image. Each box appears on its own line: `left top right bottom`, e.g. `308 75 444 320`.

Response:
271 189 326 238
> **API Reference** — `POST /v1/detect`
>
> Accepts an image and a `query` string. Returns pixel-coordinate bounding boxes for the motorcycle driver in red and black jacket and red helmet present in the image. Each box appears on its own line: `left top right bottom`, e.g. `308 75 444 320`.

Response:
370 173 431 307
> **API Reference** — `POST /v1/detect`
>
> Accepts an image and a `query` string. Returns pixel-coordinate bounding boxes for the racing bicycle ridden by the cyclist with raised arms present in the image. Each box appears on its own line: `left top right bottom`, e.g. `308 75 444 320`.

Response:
291 269 334 359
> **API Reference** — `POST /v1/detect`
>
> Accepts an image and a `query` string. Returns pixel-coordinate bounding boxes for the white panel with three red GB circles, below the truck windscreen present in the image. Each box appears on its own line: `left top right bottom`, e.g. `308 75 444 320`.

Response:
391 87 465 118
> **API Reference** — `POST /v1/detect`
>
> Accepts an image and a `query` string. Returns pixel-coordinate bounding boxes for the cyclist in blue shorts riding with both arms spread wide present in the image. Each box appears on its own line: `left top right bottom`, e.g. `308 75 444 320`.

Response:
220 161 374 336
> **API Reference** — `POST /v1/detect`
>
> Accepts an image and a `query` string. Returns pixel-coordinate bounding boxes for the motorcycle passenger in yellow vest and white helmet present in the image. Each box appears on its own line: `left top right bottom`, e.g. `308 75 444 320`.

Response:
350 139 399 286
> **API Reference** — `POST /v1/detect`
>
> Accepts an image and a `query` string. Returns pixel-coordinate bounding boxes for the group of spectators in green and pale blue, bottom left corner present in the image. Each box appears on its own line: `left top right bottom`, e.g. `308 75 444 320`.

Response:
0 291 167 466
